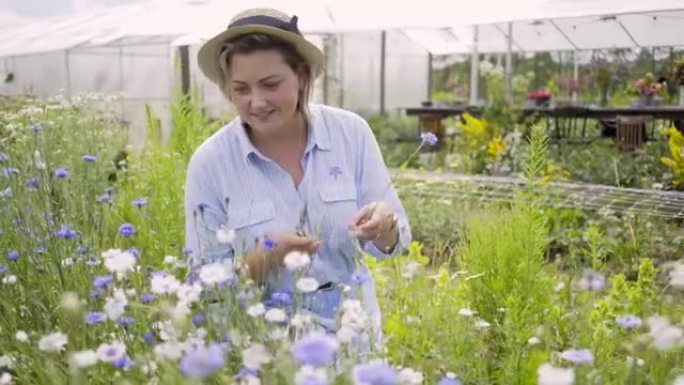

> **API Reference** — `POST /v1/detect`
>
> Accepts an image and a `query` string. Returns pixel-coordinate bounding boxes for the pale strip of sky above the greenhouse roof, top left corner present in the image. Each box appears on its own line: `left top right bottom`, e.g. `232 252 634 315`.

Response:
0 0 145 20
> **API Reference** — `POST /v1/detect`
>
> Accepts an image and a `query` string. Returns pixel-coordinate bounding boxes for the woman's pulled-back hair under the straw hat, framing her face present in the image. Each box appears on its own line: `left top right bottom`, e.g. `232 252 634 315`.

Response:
219 33 313 122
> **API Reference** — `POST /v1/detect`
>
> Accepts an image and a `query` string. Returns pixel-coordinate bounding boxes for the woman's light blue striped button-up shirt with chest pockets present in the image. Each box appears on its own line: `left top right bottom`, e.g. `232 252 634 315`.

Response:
185 105 411 328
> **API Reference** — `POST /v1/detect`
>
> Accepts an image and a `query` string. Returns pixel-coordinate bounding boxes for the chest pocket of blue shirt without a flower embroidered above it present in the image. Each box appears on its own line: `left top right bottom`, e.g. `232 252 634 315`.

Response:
228 200 276 251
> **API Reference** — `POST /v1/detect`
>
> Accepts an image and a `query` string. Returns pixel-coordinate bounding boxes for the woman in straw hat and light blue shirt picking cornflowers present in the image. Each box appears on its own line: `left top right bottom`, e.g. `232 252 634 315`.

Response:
185 9 411 340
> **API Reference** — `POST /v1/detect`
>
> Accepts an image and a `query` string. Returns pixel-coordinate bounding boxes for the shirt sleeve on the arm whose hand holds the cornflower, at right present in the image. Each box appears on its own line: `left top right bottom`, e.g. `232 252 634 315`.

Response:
355 117 411 259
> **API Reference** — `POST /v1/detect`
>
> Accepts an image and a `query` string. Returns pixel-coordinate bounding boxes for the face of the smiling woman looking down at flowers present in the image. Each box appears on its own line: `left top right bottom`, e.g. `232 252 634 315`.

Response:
227 50 304 135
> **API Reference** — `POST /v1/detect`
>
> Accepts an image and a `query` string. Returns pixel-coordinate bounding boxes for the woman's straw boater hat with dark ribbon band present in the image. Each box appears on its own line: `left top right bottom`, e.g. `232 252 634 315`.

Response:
197 8 325 84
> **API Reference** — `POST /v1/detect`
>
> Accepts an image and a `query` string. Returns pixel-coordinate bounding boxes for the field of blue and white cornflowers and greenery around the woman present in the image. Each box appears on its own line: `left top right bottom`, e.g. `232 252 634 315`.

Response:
0 96 684 385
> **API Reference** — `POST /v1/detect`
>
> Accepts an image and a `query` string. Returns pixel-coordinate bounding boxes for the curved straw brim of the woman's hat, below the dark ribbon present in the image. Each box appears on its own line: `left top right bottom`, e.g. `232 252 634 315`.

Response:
197 25 325 85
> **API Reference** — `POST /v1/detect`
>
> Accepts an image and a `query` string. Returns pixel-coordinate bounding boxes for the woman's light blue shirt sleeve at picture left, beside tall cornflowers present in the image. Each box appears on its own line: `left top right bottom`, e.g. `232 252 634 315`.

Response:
185 157 233 276
